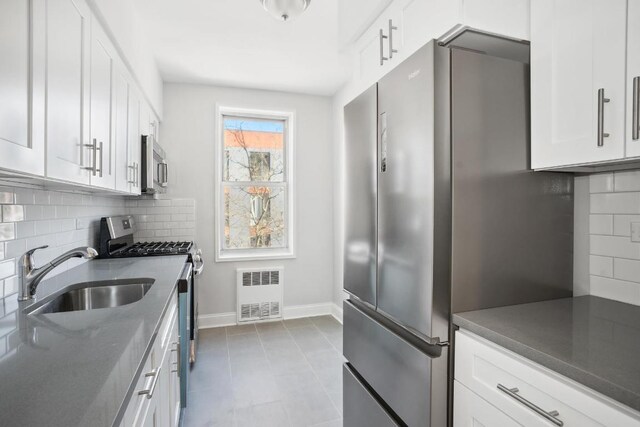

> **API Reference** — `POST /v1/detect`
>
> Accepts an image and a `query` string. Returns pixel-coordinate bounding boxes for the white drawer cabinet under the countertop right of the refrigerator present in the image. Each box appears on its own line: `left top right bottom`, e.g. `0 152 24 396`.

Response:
453 330 640 427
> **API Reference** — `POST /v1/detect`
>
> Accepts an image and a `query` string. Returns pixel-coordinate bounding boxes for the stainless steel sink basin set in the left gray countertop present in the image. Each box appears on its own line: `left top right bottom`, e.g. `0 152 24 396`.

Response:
26 278 154 314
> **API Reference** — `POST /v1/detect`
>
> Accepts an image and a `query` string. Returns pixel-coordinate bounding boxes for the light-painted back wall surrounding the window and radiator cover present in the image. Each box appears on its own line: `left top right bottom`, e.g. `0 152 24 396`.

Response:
162 84 335 315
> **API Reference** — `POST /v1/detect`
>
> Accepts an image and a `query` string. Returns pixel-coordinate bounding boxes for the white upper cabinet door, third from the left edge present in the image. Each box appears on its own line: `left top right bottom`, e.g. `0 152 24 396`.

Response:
91 20 116 188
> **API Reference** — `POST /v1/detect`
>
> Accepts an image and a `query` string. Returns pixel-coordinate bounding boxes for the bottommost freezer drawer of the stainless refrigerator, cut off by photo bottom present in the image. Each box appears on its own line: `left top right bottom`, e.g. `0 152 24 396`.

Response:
342 363 401 427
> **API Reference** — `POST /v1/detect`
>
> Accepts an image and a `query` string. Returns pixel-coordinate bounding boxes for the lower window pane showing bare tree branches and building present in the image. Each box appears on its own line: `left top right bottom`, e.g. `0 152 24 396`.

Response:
224 185 286 249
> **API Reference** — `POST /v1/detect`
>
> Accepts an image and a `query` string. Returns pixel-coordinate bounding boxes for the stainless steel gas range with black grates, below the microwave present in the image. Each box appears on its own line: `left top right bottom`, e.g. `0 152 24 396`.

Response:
99 215 204 407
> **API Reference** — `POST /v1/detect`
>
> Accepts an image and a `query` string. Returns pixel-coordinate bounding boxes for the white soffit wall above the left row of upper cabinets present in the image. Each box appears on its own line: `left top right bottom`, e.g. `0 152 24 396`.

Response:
89 0 163 119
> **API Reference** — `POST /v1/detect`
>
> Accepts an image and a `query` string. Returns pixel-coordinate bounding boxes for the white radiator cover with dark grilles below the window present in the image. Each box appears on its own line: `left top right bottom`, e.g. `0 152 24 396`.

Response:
236 267 284 323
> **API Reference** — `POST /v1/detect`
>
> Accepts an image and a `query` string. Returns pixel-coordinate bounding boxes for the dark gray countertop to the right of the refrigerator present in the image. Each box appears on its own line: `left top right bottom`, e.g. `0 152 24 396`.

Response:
453 296 640 411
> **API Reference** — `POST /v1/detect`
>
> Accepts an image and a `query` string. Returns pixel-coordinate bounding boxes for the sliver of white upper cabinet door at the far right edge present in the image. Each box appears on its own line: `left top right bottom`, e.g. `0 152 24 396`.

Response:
626 0 640 157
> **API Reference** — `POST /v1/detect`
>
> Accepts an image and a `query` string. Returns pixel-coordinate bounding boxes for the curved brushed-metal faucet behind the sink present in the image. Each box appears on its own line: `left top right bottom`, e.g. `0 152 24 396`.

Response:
18 245 98 301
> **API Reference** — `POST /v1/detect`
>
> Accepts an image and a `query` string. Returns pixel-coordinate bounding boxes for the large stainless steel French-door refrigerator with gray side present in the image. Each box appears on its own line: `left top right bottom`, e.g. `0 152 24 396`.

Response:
343 30 573 427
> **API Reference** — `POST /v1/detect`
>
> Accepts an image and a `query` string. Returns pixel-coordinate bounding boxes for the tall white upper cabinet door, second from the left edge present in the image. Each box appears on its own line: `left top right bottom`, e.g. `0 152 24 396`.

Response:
45 0 91 184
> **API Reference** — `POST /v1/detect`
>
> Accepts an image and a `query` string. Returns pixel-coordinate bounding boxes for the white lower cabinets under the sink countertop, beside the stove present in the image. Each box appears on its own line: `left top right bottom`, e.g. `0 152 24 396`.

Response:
120 296 180 427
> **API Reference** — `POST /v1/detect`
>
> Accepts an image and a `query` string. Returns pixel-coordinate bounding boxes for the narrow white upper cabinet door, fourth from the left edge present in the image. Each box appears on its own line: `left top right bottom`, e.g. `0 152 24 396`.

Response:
113 66 134 191
